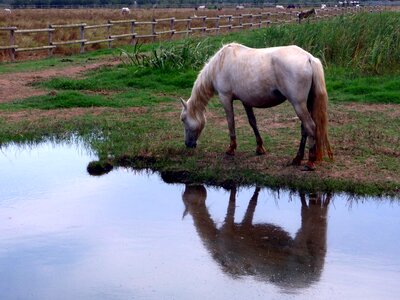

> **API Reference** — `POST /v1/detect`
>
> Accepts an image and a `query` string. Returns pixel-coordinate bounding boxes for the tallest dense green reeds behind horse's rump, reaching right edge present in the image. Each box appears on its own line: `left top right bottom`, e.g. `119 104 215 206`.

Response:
248 12 400 73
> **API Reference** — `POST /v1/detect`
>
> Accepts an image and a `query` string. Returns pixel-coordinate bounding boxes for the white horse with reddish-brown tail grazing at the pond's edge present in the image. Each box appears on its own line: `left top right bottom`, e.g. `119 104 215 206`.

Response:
181 43 333 170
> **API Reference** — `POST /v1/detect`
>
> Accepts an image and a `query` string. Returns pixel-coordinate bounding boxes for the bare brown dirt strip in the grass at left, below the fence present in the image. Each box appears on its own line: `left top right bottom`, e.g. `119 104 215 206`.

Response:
0 59 120 103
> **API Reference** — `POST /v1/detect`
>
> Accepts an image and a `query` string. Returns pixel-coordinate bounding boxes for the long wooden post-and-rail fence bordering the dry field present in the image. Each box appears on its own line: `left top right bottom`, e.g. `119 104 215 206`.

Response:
0 6 383 61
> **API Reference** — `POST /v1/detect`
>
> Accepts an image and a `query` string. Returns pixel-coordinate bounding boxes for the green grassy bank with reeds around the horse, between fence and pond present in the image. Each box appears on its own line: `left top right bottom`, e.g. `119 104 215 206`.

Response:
0 12 400 195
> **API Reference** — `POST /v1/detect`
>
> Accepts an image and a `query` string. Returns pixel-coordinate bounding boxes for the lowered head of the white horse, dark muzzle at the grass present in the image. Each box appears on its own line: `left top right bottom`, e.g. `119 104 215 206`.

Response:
181 98 205 148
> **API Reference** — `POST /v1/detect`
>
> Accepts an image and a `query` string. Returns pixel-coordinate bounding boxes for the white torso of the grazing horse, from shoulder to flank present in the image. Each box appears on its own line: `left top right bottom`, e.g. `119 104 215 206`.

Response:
214 43 312 107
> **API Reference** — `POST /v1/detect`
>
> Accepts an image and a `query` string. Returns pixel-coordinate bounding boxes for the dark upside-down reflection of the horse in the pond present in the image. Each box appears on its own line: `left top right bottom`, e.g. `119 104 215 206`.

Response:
182 185 331 290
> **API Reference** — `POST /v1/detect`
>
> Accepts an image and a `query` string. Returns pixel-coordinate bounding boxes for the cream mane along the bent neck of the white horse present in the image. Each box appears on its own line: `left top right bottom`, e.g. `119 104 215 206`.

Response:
187 44 232 125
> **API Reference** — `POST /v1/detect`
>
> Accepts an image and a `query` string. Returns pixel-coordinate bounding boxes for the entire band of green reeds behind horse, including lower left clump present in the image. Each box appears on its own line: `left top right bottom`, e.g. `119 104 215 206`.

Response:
121 12 400 74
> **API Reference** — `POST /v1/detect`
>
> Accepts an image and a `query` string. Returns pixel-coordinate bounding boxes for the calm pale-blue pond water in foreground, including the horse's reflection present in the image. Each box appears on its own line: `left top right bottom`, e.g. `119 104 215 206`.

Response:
0 143 400 300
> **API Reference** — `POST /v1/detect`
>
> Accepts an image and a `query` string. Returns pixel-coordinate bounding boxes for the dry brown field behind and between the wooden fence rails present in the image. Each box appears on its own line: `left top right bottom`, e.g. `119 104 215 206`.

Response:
0 8 360 61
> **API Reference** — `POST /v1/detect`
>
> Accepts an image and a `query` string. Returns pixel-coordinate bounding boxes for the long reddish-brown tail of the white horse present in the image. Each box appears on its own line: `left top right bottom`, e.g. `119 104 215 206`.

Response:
308 58 333 161
